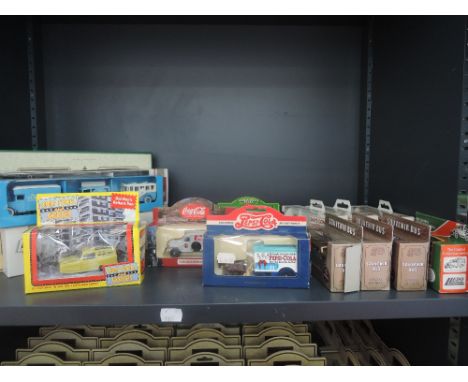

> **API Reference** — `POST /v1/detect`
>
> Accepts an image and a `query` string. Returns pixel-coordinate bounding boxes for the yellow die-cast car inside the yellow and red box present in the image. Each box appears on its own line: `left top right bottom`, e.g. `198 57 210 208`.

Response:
59 247 118 273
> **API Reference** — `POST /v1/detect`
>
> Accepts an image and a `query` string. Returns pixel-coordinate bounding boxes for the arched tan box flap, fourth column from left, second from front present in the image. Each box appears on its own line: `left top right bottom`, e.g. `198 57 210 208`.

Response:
244 337 317 359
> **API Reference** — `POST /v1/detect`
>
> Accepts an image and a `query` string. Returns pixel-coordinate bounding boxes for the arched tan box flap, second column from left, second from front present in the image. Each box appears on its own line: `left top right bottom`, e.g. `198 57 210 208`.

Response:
91 340 167 361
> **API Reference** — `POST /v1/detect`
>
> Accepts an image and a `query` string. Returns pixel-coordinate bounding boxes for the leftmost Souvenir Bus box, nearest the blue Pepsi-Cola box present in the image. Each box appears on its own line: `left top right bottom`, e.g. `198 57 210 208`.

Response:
310 214 363 292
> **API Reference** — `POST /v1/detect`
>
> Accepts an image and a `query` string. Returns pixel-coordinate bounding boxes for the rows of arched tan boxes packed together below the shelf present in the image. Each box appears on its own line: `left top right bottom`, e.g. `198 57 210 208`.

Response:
2 321 408 366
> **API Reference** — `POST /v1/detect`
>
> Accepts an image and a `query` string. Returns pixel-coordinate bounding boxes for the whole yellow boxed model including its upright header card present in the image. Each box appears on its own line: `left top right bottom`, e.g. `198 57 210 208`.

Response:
23 192 146 293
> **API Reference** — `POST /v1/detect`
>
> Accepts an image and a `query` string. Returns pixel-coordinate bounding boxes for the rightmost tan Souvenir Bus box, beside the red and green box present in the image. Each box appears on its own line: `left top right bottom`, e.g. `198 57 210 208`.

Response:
381 213 431 291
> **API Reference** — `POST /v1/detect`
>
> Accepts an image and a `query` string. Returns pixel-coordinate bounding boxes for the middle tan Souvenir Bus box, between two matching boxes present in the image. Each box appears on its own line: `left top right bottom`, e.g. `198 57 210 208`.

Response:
353 213 393 290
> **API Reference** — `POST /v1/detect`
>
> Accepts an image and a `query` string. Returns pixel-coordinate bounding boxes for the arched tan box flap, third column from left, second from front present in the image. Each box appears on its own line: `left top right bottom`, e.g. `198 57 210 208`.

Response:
169 339 242 361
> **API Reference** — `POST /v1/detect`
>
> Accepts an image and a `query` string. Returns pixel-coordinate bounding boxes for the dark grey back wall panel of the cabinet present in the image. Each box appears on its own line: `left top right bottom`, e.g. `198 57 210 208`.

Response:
42 23 363 204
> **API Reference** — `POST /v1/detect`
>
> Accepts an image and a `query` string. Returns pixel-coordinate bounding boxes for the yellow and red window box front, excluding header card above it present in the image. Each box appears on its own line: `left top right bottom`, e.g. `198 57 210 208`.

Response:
23 223 146 293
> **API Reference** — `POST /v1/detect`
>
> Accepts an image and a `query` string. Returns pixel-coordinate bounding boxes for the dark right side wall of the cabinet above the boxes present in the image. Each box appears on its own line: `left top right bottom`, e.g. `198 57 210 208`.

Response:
369 16 465 219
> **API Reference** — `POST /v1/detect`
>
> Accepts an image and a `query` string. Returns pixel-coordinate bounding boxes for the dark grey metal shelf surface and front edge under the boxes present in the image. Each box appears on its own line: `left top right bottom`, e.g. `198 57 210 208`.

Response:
0 268 468 326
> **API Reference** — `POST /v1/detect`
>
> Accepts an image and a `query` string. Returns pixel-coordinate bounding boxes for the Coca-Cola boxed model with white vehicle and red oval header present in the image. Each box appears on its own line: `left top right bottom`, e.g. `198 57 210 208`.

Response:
156 198 213 267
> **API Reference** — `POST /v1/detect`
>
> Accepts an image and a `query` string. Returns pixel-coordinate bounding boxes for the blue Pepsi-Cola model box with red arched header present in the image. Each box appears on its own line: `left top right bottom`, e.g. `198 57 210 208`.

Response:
203 205 310 288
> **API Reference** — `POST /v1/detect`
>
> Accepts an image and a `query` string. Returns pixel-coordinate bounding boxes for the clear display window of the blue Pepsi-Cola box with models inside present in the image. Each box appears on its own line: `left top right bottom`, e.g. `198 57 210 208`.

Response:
213 235 298 277
